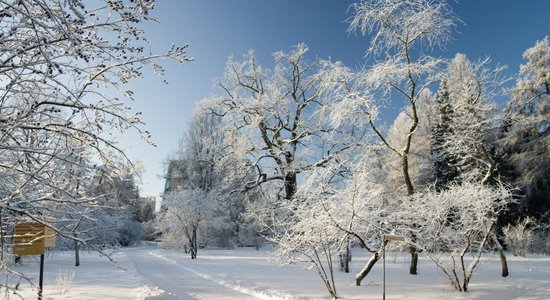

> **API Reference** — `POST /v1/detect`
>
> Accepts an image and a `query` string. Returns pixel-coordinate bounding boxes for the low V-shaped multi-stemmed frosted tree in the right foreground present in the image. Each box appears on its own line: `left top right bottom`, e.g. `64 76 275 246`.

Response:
404 182 513 292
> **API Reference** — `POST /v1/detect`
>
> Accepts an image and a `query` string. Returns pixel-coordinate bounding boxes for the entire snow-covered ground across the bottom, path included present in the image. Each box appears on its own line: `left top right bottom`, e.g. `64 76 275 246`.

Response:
8 246 550 300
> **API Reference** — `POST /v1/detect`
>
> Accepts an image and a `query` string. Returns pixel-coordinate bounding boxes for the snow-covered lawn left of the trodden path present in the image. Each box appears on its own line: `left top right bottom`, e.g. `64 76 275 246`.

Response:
9 251 161 300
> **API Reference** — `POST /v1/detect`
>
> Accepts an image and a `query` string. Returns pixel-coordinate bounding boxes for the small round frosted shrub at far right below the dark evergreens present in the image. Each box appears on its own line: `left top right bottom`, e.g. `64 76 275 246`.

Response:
502 217 535 256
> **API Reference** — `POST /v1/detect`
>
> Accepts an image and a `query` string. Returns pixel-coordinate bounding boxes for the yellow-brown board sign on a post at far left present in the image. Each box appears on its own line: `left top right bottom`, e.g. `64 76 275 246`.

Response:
13 223 46 256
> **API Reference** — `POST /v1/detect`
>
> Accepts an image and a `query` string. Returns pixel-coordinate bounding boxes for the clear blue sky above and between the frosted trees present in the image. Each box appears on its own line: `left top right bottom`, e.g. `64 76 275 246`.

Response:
121 0 550 197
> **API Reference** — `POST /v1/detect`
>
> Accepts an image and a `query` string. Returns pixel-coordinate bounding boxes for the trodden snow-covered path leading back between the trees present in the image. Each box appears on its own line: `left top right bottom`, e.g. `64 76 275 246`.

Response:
124 247 280 299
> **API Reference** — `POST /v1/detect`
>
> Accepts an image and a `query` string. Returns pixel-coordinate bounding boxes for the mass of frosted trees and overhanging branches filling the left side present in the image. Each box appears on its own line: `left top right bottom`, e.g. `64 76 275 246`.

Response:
0 0 190 298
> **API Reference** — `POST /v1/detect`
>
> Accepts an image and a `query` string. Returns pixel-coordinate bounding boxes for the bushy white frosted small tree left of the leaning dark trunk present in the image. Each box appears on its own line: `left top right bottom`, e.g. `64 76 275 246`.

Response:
248 147 385 298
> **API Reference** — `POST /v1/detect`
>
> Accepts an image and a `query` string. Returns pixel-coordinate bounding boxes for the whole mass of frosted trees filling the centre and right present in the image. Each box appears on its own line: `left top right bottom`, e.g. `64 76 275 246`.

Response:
161 0 550 298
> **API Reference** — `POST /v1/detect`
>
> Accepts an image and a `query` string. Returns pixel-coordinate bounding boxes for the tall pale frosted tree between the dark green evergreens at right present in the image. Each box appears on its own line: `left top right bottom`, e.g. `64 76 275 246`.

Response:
440 54 503 183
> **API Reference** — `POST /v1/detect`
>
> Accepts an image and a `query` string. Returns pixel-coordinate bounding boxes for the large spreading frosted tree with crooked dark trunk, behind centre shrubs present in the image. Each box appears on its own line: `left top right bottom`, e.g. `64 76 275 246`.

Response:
207 44 354 200
